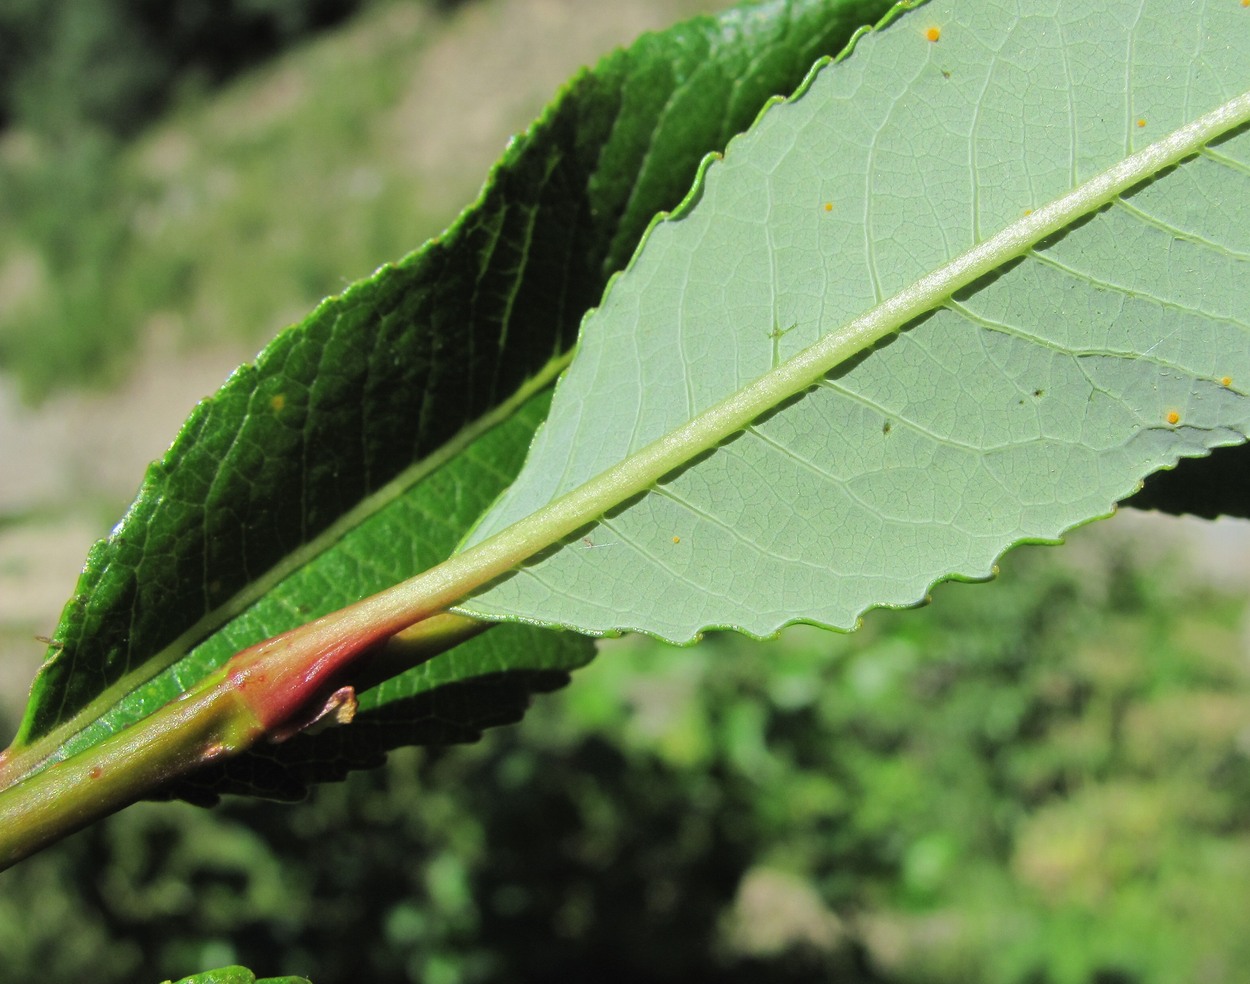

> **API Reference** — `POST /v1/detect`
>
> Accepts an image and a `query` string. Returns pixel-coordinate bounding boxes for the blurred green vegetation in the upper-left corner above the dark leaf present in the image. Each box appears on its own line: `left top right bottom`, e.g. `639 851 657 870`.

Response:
0 0 443 399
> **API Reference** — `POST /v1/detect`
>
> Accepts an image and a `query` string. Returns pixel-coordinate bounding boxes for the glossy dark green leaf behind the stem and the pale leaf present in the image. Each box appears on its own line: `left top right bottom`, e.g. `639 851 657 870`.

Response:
8 0 888 795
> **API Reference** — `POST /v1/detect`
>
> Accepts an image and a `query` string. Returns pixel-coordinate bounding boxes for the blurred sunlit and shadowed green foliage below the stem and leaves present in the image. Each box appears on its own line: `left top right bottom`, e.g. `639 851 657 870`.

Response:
7 537 1250 984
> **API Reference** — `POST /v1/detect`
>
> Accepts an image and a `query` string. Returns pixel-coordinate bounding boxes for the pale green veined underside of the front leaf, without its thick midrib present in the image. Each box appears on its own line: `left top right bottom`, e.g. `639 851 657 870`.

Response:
460 0 1250 641
